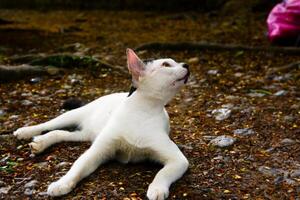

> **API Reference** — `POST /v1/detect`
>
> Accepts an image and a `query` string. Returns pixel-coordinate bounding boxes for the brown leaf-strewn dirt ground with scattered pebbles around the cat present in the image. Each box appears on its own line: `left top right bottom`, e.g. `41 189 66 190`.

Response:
0 10 300 200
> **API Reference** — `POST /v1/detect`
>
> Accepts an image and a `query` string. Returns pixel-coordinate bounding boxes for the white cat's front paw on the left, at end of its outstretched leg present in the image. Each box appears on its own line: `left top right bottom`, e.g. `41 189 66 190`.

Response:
47 180 75 197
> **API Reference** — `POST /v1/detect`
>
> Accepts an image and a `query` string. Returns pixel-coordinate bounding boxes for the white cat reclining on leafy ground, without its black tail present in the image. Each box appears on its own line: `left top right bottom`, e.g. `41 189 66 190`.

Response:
14 49 188 200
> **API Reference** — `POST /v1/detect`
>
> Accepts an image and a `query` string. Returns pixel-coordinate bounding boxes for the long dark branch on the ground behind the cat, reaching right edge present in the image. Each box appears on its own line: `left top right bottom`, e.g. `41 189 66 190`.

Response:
135 42 300 55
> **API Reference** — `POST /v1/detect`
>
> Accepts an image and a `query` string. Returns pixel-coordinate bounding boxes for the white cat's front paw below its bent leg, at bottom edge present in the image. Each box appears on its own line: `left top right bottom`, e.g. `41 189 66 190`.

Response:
147 184 169 200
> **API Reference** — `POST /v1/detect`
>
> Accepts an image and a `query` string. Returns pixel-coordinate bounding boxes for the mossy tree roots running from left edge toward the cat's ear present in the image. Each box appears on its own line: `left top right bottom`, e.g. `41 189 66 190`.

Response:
0 54 127 82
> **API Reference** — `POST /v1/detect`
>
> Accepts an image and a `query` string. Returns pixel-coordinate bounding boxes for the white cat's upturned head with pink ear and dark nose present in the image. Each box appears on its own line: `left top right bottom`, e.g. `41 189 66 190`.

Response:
127 49 190 102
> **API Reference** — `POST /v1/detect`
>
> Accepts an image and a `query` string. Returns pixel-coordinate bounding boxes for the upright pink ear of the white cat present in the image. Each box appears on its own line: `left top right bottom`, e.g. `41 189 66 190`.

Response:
126 48 145 87
